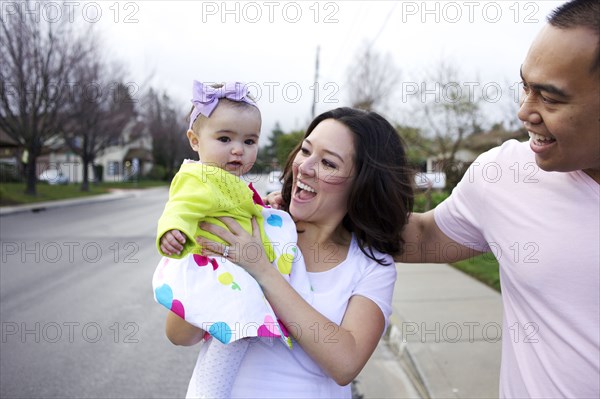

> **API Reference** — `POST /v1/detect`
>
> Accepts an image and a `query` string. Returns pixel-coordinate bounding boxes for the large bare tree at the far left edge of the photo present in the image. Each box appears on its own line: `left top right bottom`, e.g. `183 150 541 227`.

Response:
0 0 89 195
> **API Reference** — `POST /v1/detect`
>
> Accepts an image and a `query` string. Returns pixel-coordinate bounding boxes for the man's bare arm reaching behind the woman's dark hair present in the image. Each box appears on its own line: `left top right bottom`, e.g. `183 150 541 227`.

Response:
394 210 483 263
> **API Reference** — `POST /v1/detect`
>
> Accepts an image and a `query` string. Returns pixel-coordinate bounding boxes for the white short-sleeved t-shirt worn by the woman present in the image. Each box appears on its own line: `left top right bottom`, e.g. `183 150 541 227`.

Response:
188 237 396 398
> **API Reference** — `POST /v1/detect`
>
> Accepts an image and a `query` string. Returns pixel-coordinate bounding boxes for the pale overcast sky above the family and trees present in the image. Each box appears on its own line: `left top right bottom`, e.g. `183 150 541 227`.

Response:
86 0 563 134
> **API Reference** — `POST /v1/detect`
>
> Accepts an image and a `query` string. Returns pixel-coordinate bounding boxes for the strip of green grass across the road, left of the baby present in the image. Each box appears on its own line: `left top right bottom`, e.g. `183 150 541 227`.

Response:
0 180 168 206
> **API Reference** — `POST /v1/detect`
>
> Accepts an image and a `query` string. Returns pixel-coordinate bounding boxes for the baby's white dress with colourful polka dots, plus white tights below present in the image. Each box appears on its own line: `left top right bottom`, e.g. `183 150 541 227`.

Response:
152 208 312 398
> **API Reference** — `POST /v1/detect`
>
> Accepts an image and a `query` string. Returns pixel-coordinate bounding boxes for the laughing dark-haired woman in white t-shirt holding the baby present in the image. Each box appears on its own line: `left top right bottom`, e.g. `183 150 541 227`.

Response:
167 108 413 398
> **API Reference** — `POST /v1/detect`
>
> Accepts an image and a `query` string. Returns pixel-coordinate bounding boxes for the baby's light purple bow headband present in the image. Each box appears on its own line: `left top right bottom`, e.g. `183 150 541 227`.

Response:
189 80 256 129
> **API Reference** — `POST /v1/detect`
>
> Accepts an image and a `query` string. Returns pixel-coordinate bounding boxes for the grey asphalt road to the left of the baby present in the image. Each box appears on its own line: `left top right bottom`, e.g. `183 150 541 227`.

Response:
0 188 198 398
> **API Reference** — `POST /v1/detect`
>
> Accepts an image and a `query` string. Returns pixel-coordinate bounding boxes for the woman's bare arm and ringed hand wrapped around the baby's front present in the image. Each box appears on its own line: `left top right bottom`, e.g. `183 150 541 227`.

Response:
199 218 385 385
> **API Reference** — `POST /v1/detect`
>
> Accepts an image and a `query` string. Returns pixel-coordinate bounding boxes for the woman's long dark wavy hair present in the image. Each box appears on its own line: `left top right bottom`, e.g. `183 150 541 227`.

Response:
282 108 414 264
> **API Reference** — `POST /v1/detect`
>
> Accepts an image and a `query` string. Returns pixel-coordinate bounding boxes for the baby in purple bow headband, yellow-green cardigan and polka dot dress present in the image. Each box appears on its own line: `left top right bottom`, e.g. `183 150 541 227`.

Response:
153 81 311 398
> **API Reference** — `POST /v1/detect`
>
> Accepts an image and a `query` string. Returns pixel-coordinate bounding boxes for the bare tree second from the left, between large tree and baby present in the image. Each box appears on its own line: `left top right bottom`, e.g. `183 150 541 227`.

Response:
63 54 136 191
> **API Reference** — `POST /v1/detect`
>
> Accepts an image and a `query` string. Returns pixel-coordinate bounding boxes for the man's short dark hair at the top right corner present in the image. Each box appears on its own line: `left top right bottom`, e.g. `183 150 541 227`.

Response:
548 0 600 72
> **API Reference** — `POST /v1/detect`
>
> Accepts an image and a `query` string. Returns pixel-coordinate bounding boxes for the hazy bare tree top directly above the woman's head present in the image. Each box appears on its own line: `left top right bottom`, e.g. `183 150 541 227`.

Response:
347 45 400 111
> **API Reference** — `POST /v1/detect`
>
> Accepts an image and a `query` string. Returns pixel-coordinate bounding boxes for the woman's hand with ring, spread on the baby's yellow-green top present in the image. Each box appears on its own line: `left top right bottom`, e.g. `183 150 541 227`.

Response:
196 217 275 284
